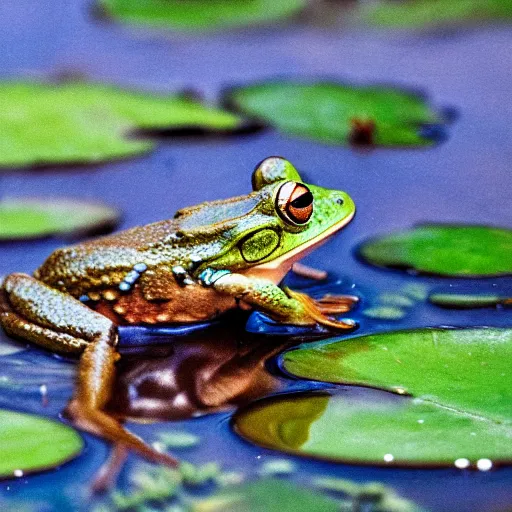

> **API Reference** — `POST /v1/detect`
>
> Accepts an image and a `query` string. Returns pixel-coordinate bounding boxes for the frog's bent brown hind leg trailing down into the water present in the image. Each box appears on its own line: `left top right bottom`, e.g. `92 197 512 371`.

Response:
0 274 177 465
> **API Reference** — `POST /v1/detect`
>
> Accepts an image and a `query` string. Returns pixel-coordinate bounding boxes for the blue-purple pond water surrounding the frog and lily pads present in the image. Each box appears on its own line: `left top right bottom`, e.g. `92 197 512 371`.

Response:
0 0 512 511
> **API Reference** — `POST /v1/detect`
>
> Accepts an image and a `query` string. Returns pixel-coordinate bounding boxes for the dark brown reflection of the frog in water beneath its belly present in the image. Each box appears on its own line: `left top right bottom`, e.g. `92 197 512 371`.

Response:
109 318 298 421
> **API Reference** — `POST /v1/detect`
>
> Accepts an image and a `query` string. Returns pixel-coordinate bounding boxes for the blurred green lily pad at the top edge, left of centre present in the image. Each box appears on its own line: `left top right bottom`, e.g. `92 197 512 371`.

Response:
98 0 308 31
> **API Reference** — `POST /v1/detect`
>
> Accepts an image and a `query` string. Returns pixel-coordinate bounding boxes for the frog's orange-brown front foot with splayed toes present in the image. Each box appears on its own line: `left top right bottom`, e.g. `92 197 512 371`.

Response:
286 288 359 330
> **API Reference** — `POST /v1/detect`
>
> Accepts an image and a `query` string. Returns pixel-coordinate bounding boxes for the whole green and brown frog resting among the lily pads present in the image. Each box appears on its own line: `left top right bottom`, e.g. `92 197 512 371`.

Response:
0 157 357 465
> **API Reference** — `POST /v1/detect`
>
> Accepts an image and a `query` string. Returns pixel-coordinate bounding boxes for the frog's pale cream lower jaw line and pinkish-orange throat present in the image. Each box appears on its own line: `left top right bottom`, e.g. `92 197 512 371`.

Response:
242 211 355 284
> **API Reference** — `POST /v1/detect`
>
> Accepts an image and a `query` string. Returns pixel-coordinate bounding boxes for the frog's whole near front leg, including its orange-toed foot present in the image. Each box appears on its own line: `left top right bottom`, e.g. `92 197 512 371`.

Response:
201 269 356 329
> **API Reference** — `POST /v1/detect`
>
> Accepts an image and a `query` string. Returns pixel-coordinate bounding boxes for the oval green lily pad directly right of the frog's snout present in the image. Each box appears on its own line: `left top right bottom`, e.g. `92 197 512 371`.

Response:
358 224 512 277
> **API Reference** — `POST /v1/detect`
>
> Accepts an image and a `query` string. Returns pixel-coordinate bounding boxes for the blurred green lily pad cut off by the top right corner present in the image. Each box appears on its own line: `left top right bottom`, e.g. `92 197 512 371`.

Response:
363 0 512 28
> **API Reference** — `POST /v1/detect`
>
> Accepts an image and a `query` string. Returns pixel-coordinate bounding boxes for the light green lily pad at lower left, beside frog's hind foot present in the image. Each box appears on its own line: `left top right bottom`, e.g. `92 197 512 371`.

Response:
0 409 83 478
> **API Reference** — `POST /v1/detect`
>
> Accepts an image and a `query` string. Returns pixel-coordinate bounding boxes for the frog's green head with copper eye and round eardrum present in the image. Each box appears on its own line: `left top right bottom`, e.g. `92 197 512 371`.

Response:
178 157 355 282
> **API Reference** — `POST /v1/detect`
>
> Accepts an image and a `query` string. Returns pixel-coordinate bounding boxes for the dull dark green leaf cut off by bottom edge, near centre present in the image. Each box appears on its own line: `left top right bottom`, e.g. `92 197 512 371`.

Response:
192 479 339 512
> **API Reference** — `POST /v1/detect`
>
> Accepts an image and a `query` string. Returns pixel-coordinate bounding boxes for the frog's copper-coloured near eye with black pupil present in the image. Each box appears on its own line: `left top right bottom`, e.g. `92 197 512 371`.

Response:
276 181 313 225
